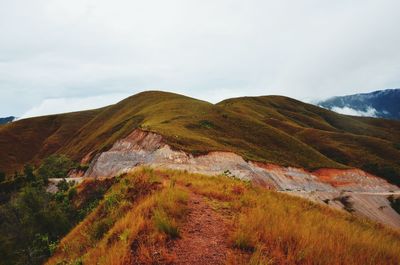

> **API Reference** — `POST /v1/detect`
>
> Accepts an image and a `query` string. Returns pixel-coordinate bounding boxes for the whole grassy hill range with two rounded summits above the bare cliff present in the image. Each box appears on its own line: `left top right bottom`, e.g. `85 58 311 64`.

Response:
0 91 400 183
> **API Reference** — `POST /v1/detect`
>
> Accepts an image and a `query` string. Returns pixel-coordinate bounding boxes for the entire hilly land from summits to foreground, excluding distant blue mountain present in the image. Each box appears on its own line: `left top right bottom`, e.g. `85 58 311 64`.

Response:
0 91 400 265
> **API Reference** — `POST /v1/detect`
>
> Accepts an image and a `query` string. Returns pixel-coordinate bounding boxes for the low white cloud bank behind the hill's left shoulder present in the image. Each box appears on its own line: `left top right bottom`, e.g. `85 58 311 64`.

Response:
19 94 128 119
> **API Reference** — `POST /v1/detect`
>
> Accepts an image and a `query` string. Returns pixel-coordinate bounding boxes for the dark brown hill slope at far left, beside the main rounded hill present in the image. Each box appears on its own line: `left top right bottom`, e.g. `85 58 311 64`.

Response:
0 110 97 173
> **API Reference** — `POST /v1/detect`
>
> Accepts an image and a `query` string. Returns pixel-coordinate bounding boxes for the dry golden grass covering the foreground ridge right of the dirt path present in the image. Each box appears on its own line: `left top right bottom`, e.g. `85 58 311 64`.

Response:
167 169 400 264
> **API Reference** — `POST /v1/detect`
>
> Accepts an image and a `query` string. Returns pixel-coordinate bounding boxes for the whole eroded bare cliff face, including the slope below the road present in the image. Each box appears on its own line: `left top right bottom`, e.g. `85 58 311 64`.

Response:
85 129 400 227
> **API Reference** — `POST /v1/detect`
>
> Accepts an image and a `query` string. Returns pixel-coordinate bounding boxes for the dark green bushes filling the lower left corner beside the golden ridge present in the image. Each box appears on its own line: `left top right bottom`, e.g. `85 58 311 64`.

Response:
0 156 112 264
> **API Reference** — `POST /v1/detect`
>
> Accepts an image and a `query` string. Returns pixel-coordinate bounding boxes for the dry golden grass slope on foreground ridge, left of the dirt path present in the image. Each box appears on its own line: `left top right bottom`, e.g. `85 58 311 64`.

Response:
47 168 187 265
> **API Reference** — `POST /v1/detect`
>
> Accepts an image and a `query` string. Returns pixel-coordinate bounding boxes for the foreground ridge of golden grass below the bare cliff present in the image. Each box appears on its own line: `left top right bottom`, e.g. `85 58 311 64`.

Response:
46 168 400 265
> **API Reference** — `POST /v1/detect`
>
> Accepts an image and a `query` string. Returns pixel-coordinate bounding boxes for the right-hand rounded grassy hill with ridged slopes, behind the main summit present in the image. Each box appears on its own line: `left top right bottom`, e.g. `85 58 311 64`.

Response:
218 96 400 184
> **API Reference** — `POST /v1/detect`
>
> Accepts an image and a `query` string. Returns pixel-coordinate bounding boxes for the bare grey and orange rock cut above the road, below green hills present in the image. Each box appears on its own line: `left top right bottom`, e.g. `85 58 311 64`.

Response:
86 129 398 192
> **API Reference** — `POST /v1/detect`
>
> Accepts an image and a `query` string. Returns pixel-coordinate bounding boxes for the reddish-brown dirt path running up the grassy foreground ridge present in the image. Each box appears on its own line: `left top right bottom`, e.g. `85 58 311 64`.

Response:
170 194 229 265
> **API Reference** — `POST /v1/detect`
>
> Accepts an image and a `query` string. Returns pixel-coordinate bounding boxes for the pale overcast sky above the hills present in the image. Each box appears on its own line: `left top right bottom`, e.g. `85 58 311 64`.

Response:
0 0 400 117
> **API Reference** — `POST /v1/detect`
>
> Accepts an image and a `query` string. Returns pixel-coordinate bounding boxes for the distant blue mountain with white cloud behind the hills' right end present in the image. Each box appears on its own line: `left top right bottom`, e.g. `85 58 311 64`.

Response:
317 89 400 120
